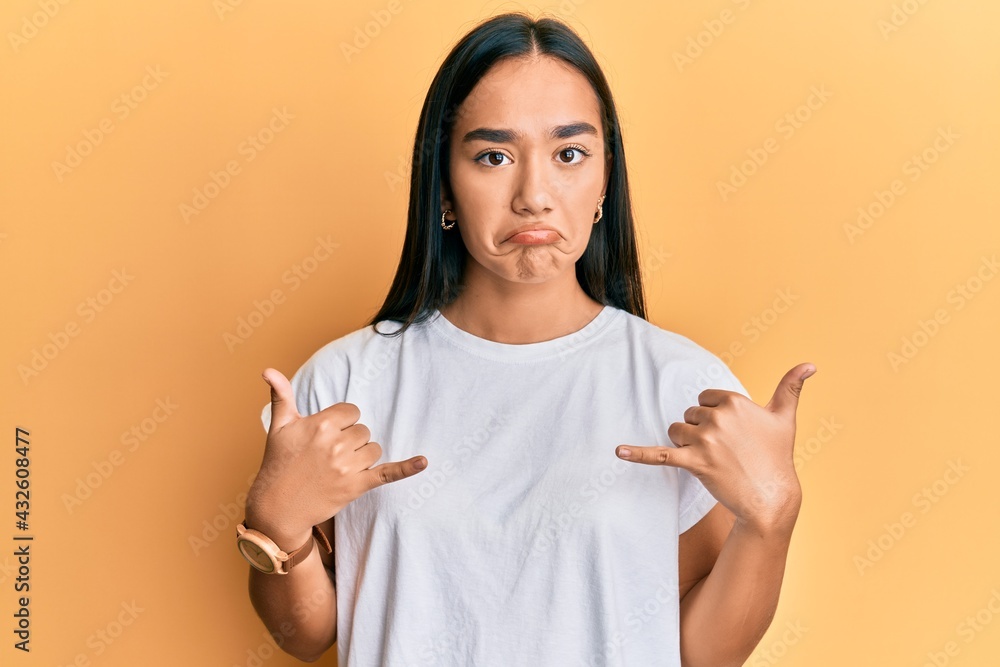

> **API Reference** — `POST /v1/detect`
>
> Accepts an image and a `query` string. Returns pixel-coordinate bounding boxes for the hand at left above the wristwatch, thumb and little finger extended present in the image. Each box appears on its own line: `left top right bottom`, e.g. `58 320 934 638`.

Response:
246 368 427 549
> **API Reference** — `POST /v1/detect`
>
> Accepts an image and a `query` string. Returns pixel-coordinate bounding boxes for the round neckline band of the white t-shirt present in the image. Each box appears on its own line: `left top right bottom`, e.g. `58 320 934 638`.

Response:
430 304 620 363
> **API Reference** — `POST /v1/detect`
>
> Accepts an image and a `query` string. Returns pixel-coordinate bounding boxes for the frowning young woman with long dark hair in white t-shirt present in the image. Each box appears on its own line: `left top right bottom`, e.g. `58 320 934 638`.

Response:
240 14 815 667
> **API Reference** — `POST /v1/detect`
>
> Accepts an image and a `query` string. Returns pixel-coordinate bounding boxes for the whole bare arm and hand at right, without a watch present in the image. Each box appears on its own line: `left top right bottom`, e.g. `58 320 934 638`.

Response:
615 364 816 667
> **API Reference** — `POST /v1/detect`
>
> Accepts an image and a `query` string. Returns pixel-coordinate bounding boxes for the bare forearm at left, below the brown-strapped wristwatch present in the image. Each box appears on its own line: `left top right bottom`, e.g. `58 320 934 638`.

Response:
247 515 337 662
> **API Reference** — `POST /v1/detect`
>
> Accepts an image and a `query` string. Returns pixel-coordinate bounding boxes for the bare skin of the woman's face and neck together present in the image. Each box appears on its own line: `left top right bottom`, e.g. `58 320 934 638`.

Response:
441 52 610 344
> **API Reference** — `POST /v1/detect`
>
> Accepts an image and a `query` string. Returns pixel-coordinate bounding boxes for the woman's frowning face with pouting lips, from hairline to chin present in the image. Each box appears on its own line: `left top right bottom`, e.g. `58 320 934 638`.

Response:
441 56 609 283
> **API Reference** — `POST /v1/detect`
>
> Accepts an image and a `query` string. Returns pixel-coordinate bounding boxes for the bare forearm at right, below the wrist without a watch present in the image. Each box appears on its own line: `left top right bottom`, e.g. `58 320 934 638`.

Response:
680 519 794 667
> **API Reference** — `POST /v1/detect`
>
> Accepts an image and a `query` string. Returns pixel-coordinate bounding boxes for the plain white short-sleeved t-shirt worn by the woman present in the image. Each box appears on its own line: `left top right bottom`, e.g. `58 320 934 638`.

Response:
261 306 749 667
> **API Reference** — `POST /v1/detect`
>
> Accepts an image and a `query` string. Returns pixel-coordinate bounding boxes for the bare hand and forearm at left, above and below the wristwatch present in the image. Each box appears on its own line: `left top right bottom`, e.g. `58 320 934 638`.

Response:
246 368 427 662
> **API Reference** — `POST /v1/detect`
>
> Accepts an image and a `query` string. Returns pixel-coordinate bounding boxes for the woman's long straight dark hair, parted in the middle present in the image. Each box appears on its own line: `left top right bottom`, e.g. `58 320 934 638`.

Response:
367 12 646 336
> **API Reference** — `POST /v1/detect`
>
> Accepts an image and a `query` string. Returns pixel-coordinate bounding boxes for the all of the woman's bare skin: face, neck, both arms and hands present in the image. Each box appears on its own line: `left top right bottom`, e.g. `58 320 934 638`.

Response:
246 51 813 667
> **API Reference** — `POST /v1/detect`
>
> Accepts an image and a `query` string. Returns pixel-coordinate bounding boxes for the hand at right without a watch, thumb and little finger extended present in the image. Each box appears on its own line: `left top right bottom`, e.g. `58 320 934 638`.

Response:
615 363 816 528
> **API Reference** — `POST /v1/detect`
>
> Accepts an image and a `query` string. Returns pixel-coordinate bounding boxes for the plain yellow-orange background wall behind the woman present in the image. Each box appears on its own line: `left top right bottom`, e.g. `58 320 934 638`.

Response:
0 0 1000 667
